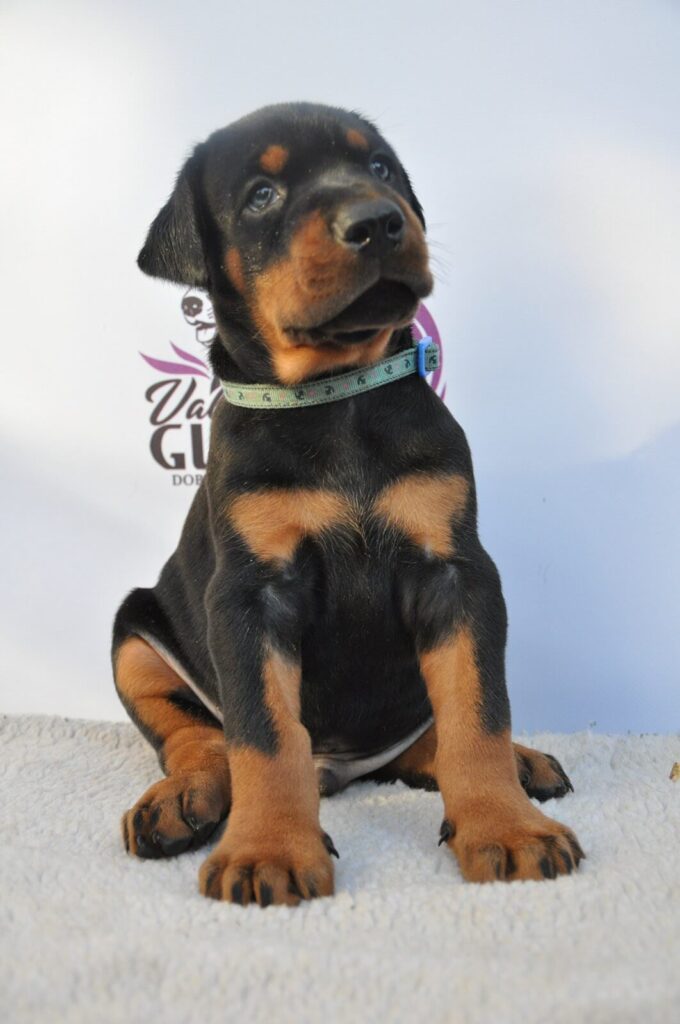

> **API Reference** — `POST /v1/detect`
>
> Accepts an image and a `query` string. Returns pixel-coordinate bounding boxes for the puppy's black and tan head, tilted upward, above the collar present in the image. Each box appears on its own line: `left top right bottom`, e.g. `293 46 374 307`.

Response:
138 103 432 384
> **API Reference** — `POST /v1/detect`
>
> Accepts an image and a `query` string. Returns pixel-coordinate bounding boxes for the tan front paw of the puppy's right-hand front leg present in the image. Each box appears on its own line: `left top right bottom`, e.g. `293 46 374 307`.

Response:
439 798 586 882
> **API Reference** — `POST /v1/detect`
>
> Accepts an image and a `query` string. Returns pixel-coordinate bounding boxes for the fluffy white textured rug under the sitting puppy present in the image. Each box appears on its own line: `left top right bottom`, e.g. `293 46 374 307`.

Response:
0 717 680 1024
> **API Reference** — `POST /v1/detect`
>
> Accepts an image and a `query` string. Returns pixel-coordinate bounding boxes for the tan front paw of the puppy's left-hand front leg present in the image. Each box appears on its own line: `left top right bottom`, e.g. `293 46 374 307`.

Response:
199 825 337 906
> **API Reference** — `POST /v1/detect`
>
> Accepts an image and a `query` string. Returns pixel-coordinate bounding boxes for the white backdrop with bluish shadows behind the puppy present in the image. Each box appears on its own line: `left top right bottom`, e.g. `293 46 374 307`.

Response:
0 0 680 731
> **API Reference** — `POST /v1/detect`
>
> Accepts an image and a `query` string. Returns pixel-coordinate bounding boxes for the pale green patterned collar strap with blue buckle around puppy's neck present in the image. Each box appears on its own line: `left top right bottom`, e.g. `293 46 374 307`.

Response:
220 338 439 409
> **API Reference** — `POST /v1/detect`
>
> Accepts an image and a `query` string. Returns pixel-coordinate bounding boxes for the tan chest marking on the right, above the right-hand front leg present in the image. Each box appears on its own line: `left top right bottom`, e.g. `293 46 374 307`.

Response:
374 473 470 558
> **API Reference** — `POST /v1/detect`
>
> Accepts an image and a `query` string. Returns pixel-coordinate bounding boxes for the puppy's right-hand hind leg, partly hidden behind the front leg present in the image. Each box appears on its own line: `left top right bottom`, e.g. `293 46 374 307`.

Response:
371 725 573 803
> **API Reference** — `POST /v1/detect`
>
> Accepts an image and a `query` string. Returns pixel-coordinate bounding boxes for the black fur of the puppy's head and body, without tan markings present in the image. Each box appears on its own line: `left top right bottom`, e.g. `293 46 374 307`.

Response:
114 104 509 770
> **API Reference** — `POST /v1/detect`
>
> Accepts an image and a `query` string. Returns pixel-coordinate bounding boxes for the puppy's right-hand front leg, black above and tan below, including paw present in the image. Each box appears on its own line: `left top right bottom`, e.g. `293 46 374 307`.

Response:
403 548 584 882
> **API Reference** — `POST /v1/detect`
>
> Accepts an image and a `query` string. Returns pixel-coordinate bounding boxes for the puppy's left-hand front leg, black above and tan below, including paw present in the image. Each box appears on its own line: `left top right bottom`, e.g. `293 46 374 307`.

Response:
200 563 333 906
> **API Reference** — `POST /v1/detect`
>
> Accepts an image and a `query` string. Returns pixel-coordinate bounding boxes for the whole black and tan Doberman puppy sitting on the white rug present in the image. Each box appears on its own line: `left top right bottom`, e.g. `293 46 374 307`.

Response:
113 103 583 906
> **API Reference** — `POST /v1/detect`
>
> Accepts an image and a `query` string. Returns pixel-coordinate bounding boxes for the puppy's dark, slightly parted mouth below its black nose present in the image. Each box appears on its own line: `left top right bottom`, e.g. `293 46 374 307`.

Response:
287 279 420 346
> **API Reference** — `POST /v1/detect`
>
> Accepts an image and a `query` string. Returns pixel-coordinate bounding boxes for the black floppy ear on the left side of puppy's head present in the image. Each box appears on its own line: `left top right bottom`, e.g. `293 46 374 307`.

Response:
137 152 208 289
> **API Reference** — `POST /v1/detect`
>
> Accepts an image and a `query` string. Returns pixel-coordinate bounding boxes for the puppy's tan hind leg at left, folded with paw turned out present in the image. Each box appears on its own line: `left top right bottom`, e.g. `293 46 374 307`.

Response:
115 636 230 857
